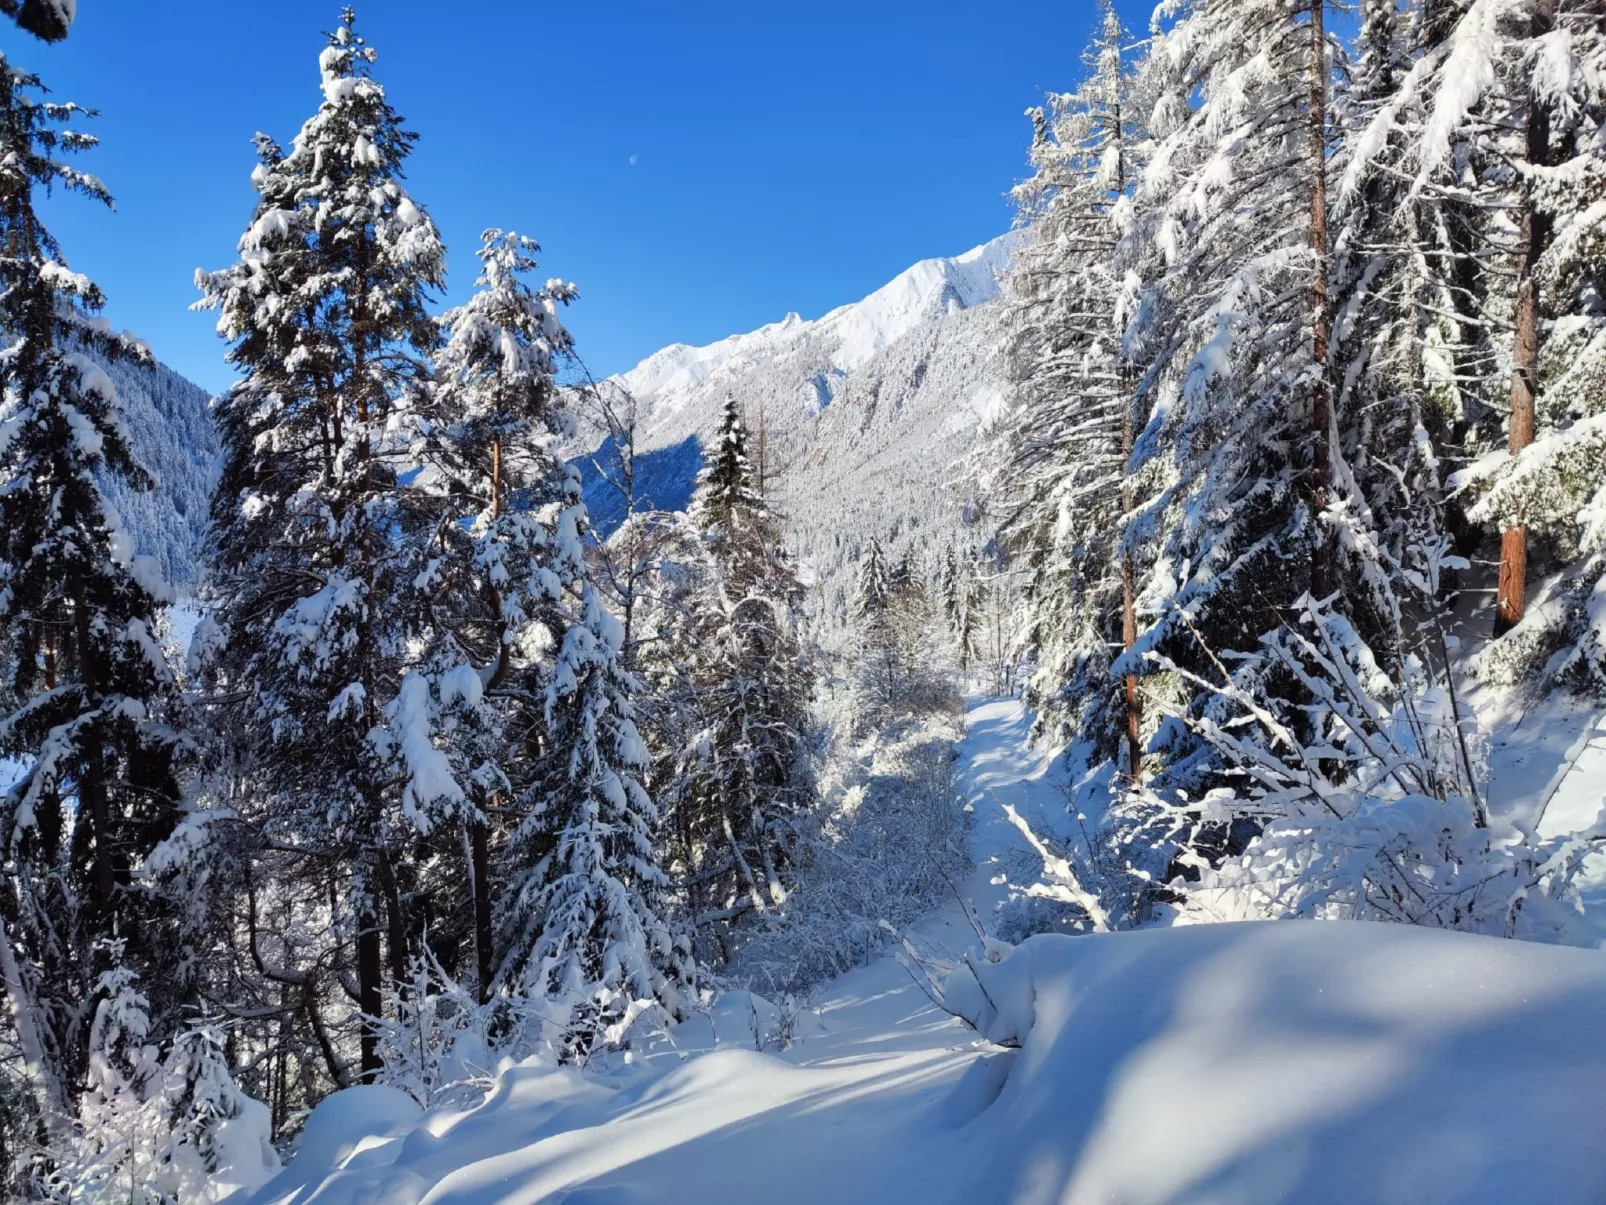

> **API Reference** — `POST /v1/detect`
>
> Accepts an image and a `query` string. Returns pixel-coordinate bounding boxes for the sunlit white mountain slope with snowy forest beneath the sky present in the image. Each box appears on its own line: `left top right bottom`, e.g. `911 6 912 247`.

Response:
588 235 1010 627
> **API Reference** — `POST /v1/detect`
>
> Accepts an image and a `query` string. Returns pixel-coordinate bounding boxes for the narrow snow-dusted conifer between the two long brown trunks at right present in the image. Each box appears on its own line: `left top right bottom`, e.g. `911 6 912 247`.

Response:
1291 0 1474 684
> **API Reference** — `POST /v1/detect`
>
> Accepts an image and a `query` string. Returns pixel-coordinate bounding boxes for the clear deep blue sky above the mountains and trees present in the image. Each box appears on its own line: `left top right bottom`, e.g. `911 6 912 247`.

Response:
15 0 1147 389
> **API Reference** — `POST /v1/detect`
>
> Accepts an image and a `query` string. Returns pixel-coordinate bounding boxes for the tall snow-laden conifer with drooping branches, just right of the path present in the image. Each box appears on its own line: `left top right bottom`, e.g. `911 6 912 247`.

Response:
1116 0 1341 786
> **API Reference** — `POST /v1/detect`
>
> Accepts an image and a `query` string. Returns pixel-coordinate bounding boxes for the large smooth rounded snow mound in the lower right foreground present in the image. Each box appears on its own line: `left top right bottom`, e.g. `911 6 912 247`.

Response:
952 922 1606 1205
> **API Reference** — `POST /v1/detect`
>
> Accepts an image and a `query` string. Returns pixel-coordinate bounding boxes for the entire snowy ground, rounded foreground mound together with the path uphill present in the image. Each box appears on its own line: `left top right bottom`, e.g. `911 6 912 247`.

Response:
237 701 1606 1205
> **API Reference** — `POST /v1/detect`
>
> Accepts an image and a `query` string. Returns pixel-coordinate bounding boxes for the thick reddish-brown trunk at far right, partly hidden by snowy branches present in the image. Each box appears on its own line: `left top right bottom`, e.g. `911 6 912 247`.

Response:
1495 0 1556 636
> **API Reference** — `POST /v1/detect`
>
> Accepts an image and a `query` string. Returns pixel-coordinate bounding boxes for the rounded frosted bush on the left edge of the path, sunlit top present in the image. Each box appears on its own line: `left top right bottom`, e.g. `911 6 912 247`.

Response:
728 718 968 996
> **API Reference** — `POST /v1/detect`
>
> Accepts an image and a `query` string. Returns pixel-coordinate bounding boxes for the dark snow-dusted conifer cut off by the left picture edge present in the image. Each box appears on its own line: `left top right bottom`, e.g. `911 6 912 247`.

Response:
0 49 180 1163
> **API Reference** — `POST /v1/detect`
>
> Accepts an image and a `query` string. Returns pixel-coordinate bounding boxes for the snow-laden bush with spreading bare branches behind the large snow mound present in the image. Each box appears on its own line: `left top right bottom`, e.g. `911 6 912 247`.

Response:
1148 598 1592 942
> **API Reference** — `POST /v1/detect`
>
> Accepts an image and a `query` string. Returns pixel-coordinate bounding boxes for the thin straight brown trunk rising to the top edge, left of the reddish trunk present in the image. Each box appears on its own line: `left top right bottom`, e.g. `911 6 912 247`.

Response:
1309 0 1333 598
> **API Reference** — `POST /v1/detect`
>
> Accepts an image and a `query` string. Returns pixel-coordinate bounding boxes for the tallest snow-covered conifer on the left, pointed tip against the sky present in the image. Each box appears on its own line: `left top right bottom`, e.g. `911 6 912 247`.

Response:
198 8 446 1076
